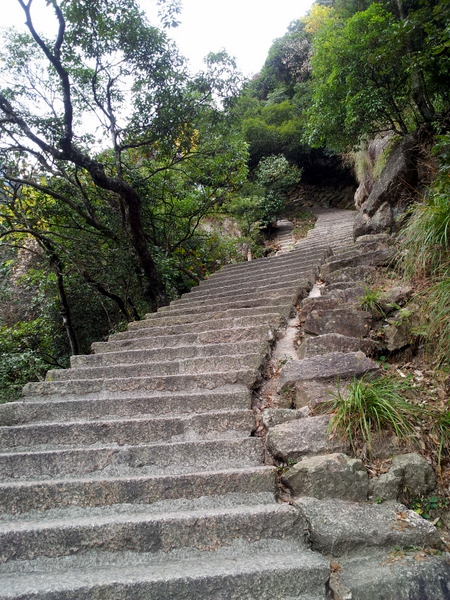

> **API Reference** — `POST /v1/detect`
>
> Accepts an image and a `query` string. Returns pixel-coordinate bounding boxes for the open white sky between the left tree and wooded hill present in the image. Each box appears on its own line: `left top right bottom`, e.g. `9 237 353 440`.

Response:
0 0 313 76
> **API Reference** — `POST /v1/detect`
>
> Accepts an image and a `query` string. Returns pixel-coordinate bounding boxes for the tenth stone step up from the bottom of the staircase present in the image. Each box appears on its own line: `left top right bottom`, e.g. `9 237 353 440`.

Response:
92 324 276 353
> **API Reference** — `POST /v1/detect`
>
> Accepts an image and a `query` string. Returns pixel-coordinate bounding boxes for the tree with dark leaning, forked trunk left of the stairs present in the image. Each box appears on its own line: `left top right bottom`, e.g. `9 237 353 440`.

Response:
0 0 245 309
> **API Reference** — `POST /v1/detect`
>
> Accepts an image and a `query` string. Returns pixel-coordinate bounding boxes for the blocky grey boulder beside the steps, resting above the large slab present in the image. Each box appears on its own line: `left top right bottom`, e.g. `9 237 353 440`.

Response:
282 454 369 502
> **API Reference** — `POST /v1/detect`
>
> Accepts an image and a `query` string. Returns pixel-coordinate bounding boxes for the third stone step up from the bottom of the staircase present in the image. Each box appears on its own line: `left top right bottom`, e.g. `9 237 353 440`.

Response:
0 466 276 521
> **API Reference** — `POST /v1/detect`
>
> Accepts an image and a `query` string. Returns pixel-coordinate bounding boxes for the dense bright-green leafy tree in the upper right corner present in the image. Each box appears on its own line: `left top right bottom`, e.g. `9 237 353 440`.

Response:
307 0 450 151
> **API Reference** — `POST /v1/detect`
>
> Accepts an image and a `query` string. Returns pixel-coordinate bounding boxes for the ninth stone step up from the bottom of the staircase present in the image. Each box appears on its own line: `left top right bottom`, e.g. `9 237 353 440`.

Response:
70 341 269 369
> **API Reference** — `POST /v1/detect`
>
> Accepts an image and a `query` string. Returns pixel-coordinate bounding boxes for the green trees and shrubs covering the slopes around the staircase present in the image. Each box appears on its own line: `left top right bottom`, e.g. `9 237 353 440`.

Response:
0 0 450 404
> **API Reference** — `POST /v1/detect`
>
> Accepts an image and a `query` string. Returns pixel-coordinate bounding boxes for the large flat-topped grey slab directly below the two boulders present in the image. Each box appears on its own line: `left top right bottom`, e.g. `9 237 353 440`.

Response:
296 498 441 556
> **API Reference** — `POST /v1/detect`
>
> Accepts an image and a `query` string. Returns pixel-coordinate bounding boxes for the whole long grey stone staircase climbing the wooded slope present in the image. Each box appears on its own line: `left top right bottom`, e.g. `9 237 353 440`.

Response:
0 210 441 600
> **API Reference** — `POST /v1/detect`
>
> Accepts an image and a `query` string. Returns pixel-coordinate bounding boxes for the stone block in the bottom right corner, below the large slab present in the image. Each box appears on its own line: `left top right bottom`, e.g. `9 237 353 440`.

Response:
331 547 450 600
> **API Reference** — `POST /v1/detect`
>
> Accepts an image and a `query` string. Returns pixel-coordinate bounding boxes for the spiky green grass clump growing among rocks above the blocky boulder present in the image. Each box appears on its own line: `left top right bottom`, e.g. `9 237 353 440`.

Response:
328 375 423 454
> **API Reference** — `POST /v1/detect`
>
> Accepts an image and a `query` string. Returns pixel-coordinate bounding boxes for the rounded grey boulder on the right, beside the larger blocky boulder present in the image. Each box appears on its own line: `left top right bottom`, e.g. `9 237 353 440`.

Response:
370 452 436 500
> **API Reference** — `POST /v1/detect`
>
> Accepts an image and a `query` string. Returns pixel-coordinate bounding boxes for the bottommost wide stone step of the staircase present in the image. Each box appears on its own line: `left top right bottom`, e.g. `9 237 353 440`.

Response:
0 539 330 600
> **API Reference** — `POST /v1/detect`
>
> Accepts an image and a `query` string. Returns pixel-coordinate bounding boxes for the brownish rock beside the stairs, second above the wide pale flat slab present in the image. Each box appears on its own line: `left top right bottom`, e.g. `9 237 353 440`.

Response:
305 308 372 337
